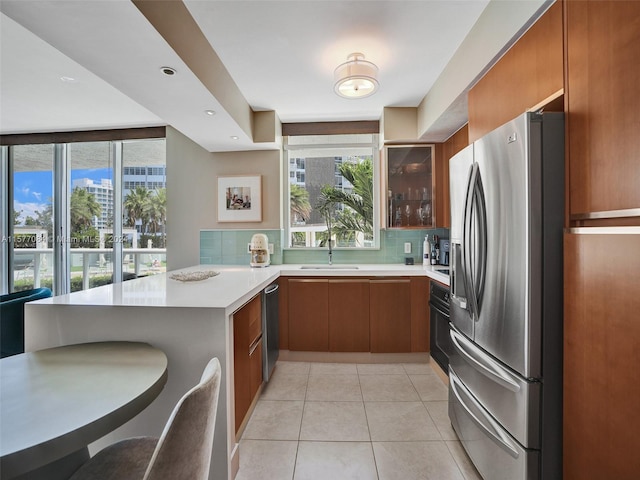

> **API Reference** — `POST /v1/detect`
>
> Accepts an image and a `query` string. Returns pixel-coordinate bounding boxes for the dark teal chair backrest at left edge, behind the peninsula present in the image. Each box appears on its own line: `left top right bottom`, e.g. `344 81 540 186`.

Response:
0 287 51 358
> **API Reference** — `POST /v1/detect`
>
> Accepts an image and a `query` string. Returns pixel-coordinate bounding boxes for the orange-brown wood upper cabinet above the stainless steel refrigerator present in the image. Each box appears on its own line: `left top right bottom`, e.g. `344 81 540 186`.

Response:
468 1 564 142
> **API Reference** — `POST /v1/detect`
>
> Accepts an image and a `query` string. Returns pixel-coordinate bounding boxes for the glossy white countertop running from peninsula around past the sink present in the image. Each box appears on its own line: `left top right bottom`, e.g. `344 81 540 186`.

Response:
31 264 449 313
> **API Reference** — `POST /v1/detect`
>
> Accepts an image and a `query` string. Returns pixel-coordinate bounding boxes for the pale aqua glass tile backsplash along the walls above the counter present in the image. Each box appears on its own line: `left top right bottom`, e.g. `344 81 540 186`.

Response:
200 228 449 265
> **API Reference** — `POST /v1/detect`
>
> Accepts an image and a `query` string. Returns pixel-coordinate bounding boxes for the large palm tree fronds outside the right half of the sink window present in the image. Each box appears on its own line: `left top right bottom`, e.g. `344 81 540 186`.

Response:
316 159 373 246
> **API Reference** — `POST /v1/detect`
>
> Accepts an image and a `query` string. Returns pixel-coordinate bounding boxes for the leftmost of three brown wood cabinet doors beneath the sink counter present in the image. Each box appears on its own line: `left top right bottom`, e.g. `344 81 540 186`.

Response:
289 278 329 352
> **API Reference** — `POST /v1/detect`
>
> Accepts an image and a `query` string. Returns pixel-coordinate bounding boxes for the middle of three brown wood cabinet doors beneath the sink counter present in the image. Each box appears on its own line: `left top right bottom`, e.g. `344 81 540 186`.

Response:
329 279 369 352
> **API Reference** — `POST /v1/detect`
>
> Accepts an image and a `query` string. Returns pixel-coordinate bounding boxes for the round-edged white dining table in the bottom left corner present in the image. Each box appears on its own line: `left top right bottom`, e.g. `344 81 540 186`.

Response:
0 341 167 480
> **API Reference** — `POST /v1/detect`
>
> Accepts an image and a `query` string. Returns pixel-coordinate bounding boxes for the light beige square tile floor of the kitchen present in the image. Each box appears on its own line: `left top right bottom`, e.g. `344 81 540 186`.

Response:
236 362 481 480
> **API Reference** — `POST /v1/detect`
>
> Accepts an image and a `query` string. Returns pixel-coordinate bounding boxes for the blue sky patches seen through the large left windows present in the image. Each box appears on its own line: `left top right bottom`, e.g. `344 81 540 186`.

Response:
13 168 112 223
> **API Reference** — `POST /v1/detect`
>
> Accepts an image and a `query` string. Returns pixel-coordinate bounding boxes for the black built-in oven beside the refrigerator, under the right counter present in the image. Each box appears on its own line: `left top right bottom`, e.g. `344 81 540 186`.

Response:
429 280 452 375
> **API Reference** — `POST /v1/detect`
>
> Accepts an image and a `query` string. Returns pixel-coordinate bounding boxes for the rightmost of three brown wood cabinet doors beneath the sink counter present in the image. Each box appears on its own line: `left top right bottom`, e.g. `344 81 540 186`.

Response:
369 278 411 353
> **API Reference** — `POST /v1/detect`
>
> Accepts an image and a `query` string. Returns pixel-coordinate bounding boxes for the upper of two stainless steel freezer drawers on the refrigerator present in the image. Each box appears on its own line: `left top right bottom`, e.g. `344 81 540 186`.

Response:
449 328 541 448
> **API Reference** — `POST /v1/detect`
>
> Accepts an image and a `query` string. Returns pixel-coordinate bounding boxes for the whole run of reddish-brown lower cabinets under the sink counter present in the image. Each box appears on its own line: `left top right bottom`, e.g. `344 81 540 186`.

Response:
280 277 429 353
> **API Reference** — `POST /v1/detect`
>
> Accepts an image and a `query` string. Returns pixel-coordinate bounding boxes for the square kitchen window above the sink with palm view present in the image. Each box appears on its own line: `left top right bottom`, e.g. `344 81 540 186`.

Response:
285 134 379 248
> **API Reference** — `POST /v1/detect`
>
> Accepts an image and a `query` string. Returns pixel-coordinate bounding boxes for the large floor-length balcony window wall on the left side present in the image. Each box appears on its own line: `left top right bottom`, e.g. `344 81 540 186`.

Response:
0 134 167 294
